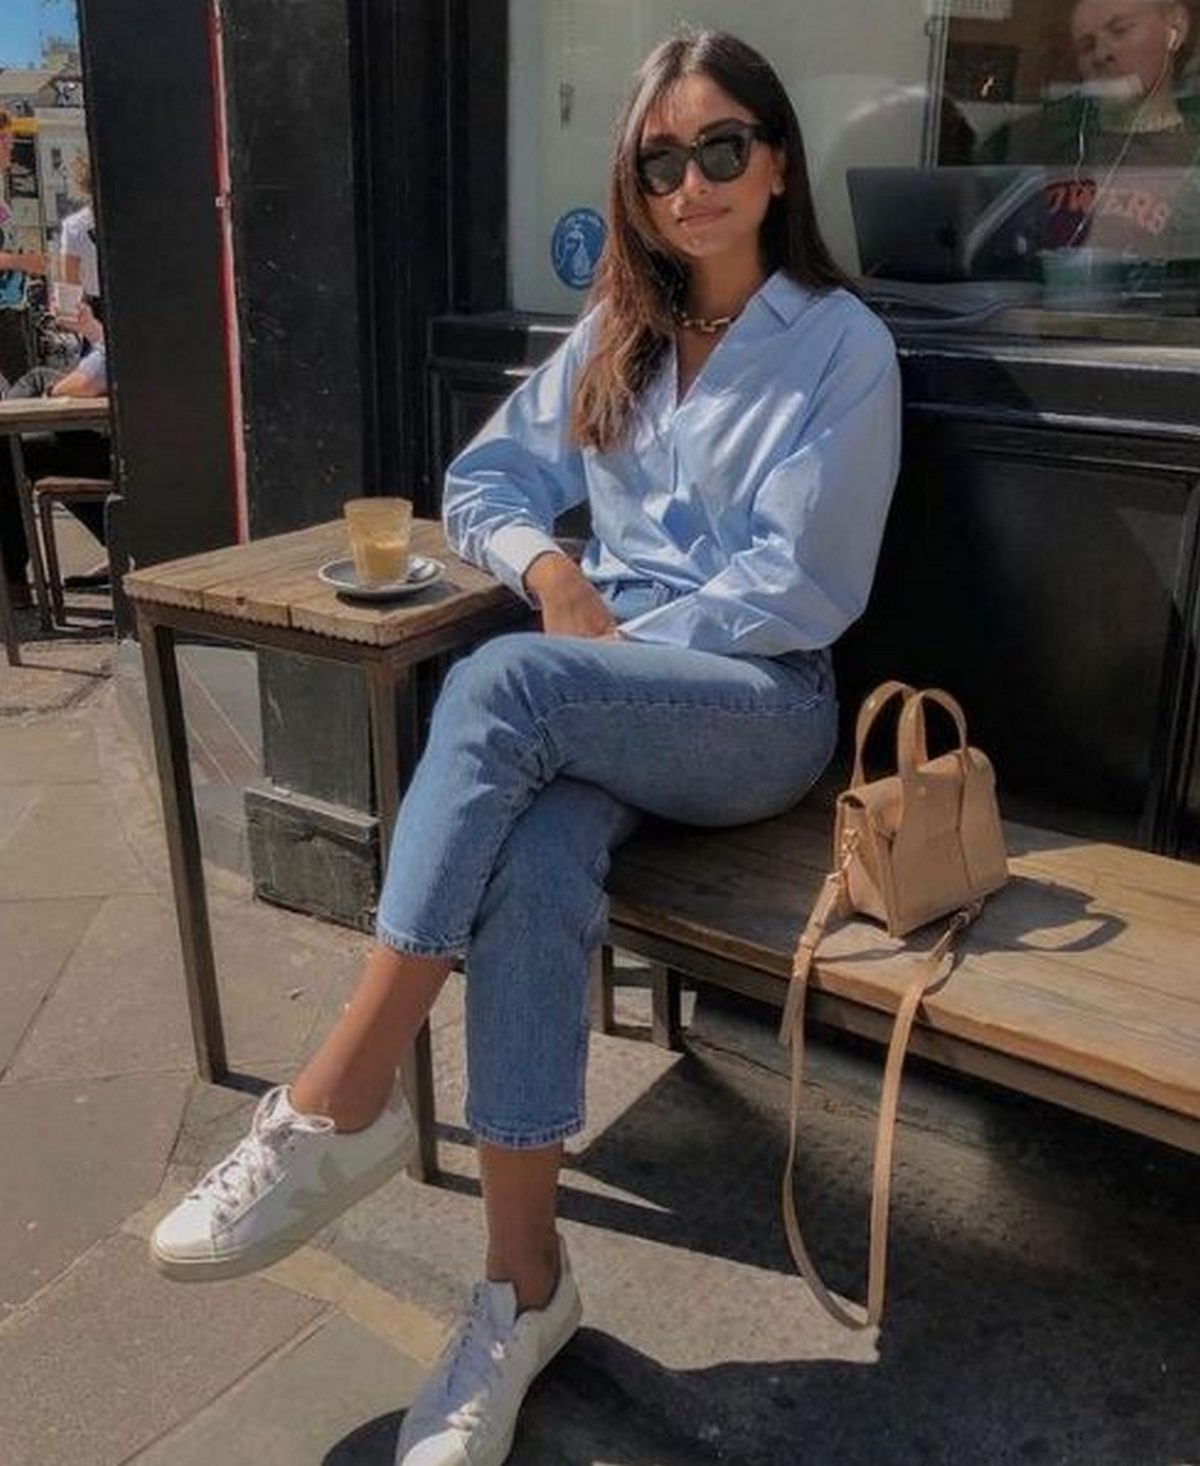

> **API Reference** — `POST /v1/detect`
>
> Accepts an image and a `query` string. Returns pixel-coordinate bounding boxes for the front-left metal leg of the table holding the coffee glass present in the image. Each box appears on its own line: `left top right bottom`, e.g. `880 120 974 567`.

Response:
138 610 229 1083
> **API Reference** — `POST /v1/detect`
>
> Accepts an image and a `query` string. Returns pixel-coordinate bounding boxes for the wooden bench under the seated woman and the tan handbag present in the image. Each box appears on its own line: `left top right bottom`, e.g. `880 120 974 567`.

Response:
596 805 1200 1151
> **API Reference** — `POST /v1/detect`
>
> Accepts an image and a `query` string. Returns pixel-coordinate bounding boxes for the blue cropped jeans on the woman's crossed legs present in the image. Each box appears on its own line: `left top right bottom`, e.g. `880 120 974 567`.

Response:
378 595 837 1148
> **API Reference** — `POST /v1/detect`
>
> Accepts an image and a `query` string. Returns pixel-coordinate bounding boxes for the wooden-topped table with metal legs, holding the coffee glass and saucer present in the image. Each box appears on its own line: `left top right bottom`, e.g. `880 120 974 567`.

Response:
125 520 529 1179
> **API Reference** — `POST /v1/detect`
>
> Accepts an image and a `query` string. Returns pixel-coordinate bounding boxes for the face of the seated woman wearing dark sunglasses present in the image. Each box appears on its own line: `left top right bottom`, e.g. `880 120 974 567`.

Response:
640 76 784 269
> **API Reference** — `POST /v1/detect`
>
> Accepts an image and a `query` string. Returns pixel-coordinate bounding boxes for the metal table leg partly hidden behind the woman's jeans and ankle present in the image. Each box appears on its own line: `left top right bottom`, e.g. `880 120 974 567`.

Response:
368 658 438 1182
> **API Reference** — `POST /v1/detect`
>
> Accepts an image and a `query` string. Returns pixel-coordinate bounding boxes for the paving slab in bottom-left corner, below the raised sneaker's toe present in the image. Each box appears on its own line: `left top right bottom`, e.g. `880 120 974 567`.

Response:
0 1236 324 1466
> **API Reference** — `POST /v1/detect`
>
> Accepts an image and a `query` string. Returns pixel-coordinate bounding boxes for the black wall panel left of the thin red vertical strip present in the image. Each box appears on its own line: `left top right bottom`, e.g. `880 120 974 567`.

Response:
79 0 236 564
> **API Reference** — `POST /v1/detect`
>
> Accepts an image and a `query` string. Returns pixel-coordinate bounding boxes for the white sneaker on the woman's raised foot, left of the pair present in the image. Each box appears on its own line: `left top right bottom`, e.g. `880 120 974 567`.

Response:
149 1085 416 1283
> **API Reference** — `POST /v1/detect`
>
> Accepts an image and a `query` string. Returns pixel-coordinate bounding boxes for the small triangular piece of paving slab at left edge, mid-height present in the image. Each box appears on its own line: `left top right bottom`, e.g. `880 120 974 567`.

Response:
0 891 101 1076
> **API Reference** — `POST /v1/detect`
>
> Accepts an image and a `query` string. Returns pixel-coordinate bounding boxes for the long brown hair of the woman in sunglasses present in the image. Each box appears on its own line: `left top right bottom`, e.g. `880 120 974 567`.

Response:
571 31 853 452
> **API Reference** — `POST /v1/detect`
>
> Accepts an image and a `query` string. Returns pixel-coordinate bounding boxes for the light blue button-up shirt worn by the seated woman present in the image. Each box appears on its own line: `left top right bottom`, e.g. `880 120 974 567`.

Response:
442 273 900 657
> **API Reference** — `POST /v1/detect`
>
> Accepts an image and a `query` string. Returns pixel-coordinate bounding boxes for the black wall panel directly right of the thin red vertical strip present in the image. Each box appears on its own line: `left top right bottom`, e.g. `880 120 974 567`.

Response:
224 0 365 538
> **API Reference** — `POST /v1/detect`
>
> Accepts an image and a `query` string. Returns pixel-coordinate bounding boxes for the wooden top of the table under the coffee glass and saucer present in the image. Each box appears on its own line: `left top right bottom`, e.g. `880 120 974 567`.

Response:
123 519 526 647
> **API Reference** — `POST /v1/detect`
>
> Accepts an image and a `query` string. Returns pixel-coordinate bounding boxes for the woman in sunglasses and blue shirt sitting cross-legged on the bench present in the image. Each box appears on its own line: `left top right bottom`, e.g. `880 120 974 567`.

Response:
154 25 898 1466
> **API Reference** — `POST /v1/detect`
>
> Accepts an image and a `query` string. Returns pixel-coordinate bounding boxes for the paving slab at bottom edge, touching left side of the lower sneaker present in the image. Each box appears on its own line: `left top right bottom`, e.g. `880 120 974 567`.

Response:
133 1318 425 1466
